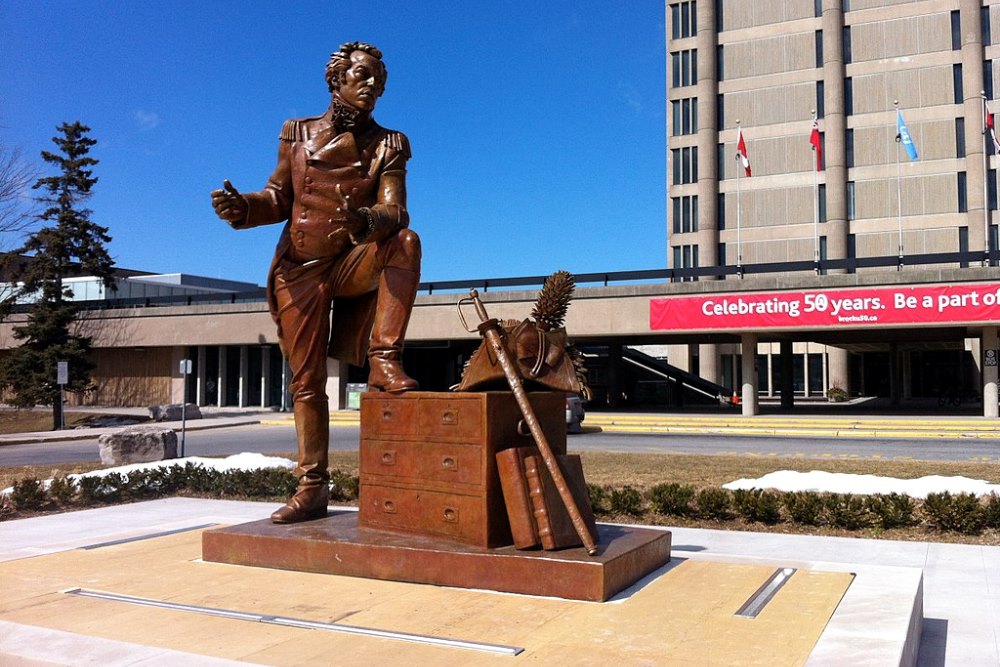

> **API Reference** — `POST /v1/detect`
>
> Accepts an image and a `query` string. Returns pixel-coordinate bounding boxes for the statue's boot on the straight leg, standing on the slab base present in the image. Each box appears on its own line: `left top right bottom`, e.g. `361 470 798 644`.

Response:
271 399 330 523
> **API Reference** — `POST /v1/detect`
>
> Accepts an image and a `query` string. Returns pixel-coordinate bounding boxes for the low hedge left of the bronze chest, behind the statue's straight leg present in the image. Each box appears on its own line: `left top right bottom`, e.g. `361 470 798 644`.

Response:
3 463 358 511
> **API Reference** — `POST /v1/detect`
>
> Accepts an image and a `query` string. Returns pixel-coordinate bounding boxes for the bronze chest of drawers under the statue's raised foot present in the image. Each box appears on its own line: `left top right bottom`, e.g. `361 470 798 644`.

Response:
358 392 566 548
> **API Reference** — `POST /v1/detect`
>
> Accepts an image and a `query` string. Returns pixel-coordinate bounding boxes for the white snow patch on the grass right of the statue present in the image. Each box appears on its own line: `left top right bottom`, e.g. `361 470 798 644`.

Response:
722 470 1000 498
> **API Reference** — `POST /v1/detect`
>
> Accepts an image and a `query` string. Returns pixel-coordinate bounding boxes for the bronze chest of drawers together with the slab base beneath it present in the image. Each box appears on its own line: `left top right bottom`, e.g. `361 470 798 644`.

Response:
202 392 671 602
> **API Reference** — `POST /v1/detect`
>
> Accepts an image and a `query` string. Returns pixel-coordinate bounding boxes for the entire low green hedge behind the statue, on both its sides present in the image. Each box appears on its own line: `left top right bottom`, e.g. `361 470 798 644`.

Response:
0 470 1000 535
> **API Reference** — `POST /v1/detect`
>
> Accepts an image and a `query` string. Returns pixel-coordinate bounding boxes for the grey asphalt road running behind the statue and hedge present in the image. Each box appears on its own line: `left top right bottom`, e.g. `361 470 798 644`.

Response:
0 425 1000 467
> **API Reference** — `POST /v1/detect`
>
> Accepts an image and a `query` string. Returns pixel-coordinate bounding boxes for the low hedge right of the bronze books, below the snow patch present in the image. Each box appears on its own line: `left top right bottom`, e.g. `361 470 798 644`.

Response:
587 483 1000 535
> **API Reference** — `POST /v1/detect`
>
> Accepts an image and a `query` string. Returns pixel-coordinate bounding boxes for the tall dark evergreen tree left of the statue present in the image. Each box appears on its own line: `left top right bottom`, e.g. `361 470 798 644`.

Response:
0 121 115 428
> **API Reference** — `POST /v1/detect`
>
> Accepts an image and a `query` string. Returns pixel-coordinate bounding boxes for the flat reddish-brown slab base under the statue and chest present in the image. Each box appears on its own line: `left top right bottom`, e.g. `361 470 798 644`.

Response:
202 512 671 602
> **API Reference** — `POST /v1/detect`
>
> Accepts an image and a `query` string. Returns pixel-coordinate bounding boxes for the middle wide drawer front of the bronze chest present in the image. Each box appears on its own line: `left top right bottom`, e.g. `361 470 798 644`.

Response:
361 440 486 487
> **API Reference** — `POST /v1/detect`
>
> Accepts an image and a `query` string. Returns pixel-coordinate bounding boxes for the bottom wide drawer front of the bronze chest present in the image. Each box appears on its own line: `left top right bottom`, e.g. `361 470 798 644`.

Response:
358 484 490 547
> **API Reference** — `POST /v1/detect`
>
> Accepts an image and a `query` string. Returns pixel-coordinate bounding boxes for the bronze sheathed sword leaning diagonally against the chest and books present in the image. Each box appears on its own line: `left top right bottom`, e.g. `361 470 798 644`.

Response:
458 288 597 556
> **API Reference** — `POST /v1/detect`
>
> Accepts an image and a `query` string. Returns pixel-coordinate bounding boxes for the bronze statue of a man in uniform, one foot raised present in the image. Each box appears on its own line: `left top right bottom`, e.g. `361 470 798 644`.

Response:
212 42 420 523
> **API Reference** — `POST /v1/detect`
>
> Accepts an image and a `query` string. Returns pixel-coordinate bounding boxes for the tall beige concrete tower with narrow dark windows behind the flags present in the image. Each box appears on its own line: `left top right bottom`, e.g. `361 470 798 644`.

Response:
665 0 1000 408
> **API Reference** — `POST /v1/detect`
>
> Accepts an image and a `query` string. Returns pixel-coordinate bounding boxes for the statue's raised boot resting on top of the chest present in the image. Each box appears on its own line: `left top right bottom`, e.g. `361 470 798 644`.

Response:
368 266 420 393
